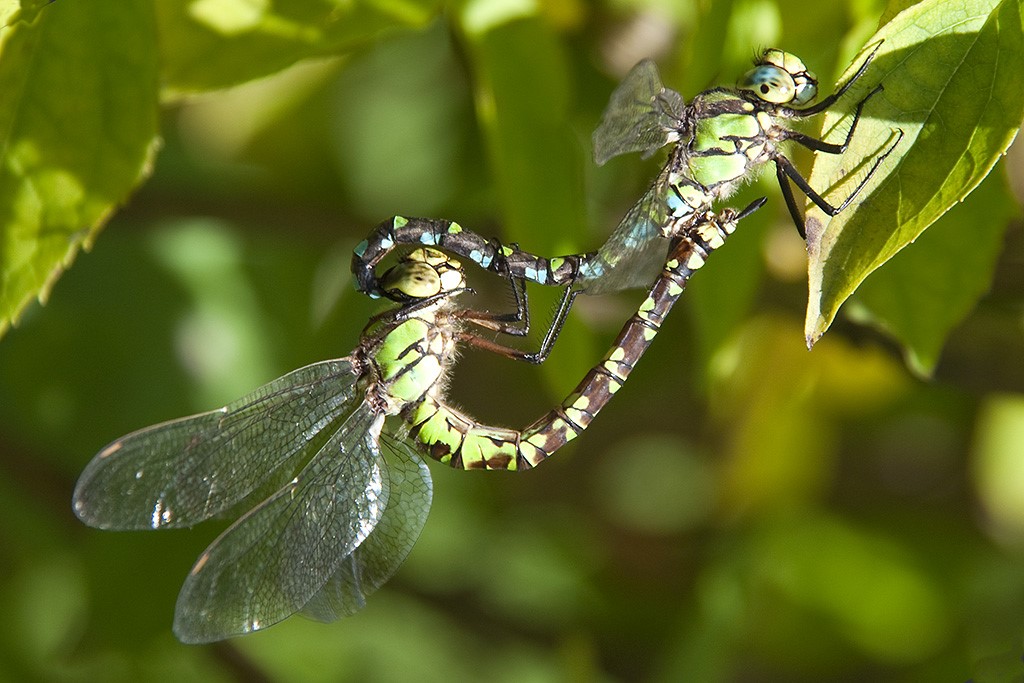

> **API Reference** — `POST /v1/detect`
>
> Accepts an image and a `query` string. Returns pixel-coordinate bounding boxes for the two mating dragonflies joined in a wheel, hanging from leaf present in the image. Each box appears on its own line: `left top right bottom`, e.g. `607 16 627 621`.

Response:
74 42 899 643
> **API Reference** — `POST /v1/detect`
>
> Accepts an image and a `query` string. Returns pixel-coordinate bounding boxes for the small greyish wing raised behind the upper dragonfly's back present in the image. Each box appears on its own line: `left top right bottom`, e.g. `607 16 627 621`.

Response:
594 59 686 165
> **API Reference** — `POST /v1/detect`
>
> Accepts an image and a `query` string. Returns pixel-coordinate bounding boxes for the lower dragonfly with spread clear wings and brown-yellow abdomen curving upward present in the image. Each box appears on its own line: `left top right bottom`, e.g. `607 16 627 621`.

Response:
73 200 764 643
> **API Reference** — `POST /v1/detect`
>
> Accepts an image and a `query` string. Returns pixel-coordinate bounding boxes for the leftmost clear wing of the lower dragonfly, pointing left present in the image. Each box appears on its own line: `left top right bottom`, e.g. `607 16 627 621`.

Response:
74 358 361 529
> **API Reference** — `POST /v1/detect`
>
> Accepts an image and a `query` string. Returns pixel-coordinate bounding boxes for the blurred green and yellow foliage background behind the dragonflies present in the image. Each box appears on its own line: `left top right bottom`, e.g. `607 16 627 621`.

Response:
0 0 1024 683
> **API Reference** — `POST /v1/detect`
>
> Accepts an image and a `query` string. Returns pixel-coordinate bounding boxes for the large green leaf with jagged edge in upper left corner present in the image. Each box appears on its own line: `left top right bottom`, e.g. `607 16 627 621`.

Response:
0 0 158 334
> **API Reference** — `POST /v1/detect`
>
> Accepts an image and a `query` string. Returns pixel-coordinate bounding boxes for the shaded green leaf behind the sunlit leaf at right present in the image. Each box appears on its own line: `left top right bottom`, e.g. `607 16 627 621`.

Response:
839 167 1018 376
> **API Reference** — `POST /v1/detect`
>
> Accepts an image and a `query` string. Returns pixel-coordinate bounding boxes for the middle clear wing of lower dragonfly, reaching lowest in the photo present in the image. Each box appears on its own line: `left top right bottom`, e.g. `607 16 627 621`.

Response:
174 403 390 643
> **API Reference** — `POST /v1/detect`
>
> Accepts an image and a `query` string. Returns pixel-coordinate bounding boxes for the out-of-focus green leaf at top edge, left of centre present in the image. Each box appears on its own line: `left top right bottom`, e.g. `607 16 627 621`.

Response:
156 0 439 92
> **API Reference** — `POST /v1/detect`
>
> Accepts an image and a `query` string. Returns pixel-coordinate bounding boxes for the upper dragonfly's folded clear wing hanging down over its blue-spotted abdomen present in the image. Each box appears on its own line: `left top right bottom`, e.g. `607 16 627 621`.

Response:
578 165 671 294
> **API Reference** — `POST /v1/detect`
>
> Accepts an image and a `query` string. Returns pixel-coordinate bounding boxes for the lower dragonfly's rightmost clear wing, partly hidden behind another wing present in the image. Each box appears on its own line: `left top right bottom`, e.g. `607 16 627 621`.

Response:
302 419 433 622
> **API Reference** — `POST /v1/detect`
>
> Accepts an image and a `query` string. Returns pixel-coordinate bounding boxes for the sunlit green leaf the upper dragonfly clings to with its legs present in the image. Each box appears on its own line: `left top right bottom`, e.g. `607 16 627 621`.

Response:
805 0 1024 345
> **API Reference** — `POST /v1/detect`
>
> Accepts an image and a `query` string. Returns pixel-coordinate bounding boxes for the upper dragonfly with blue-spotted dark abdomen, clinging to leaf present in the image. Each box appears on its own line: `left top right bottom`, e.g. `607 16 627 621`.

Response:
352 43 902 362
